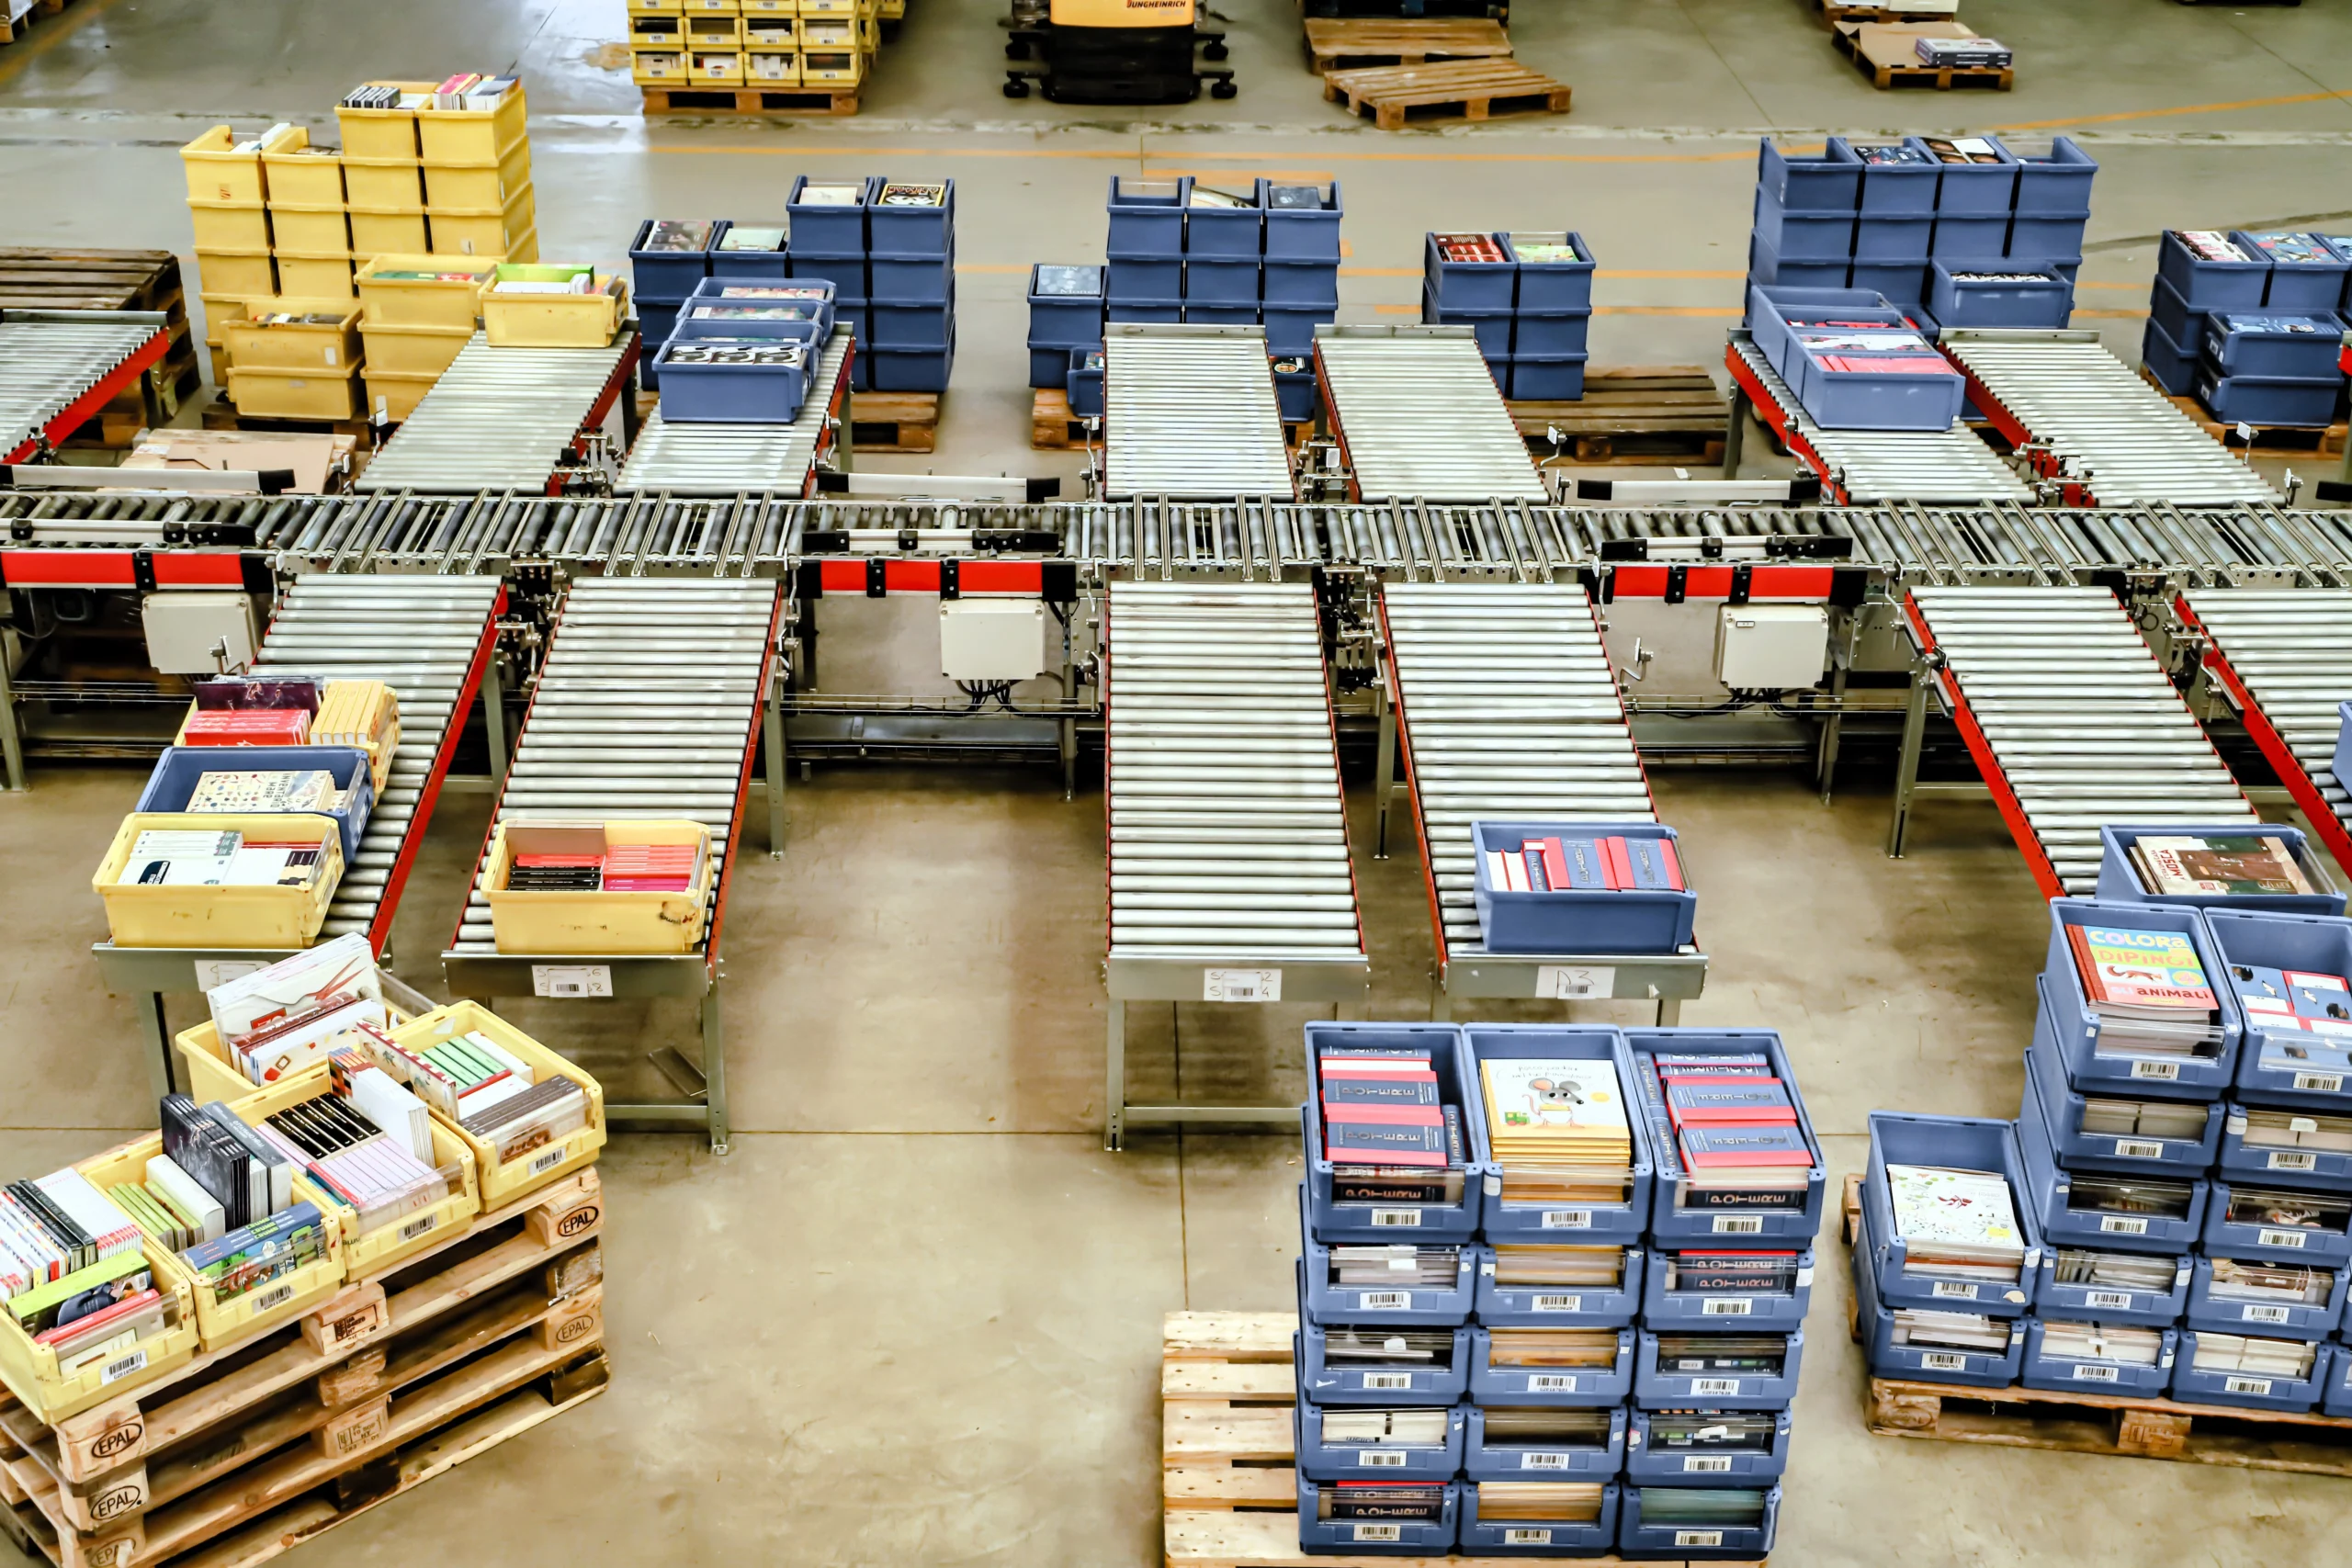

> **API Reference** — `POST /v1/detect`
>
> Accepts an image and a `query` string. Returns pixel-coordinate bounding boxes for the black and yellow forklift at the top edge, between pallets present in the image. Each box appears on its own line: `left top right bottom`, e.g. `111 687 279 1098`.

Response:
1004 0 1238 104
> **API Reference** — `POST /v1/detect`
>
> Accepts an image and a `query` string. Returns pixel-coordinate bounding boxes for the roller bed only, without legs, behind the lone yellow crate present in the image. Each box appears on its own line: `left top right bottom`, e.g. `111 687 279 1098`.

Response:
452 579 776 957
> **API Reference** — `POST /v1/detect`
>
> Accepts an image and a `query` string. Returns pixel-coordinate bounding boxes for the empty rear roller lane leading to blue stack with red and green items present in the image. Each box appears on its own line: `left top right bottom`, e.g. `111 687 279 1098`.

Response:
1315 327 1550 505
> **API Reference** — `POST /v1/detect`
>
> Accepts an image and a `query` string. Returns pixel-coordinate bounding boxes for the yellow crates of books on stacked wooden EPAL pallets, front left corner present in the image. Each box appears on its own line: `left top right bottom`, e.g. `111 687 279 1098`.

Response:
0 938 606 1568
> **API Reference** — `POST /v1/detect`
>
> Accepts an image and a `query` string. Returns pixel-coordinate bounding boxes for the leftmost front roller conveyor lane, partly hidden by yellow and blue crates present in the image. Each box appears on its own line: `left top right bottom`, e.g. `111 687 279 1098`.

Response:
254 571 505 950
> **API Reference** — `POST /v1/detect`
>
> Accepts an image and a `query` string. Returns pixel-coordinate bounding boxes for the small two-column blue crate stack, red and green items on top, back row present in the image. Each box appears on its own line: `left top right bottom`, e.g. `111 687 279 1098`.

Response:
1420 231 1595 402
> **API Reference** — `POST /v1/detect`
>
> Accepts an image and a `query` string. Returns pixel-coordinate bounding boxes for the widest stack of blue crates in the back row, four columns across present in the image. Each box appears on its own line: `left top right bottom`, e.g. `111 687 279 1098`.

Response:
1747 136 2098 329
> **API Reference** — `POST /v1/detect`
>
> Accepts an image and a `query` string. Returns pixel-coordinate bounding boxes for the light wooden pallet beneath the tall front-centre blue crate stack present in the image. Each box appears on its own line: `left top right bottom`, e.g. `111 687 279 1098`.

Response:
1159 1312 1761 1568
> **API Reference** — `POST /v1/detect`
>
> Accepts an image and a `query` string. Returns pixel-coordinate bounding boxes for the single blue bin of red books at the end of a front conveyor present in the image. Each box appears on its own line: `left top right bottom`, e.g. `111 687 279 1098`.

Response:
1470 820 1698 952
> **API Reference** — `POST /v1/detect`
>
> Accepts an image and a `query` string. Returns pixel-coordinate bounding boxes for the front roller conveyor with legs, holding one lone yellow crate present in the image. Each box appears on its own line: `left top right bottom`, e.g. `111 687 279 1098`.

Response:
442 579 781 1149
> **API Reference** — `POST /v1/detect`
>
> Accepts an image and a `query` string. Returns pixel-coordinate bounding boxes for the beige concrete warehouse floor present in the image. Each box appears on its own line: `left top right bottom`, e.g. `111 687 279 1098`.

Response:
0 0 2352 1568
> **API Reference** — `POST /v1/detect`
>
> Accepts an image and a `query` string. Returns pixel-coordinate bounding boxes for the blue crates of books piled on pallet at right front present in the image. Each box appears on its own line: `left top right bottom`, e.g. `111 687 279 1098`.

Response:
1853 825 2352 1450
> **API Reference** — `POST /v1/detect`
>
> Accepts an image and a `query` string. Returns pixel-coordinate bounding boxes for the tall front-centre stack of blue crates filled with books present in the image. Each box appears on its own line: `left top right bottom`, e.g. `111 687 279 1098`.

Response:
1294 1025 1823 1561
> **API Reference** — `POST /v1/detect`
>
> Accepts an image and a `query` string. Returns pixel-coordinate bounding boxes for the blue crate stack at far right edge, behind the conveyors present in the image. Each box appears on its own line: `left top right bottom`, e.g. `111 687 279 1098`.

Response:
2141 231 2352 425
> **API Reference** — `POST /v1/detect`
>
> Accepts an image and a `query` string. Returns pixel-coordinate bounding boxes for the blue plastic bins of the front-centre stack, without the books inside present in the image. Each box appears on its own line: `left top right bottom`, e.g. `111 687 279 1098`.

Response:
1296 1025 1823 1561
